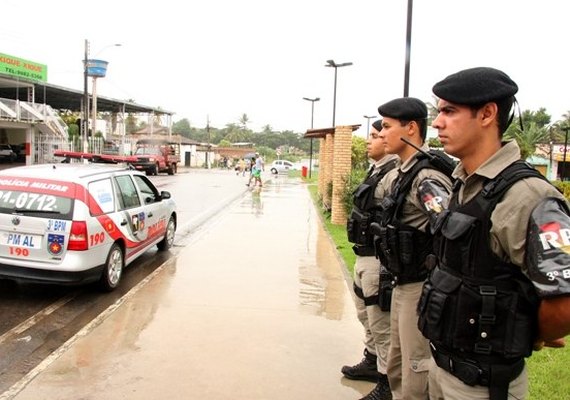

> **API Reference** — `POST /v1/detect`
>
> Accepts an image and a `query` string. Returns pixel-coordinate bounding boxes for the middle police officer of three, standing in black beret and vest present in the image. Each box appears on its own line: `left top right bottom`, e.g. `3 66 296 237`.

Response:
376 97 451 400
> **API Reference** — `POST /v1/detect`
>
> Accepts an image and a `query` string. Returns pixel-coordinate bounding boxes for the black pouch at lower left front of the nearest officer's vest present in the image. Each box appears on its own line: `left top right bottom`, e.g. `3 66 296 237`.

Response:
418 268 462 344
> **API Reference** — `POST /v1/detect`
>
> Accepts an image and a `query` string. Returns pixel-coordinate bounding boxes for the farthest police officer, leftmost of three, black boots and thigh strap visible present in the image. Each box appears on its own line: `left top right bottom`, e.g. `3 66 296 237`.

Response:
341 120 399 400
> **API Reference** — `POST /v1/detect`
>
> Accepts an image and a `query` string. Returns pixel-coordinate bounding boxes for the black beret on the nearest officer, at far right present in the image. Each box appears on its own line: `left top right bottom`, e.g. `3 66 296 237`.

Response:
432 67 519 105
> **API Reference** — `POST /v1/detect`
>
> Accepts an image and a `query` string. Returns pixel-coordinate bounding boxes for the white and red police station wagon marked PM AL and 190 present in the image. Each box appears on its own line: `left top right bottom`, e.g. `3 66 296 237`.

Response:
0 163 177 291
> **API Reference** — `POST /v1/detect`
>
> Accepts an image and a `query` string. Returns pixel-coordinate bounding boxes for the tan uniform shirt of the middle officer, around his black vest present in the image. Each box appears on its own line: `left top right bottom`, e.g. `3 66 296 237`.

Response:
374 144 451 232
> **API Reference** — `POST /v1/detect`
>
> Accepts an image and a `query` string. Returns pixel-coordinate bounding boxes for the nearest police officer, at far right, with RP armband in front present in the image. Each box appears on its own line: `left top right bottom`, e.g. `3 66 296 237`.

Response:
419 67 570 400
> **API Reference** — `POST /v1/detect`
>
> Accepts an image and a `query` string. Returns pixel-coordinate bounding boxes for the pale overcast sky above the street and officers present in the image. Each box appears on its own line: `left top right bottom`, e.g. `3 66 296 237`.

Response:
0 0 570 136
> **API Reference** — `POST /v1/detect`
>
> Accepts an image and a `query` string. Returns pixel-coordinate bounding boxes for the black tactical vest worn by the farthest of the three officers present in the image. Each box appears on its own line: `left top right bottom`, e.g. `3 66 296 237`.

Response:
346 160 397 256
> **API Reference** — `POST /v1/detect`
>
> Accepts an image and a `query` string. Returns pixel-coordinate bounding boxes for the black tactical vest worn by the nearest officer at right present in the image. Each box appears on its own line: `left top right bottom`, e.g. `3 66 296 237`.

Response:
418 161 544 364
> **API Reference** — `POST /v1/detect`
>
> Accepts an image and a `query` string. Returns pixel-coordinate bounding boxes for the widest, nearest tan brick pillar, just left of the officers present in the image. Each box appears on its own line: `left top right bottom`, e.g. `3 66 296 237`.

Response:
331 126 352 225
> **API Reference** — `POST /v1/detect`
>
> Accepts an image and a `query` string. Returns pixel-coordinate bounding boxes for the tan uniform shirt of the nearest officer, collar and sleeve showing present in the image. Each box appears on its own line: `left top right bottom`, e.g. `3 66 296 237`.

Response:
453 140 564 271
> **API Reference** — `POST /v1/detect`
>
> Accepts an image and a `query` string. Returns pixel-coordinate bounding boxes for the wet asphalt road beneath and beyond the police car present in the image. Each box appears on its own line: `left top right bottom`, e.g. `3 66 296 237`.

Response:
0 170 251 395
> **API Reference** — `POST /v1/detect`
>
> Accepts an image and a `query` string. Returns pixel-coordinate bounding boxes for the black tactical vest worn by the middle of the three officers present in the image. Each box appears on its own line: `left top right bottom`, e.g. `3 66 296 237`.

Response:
373 150 454 284
